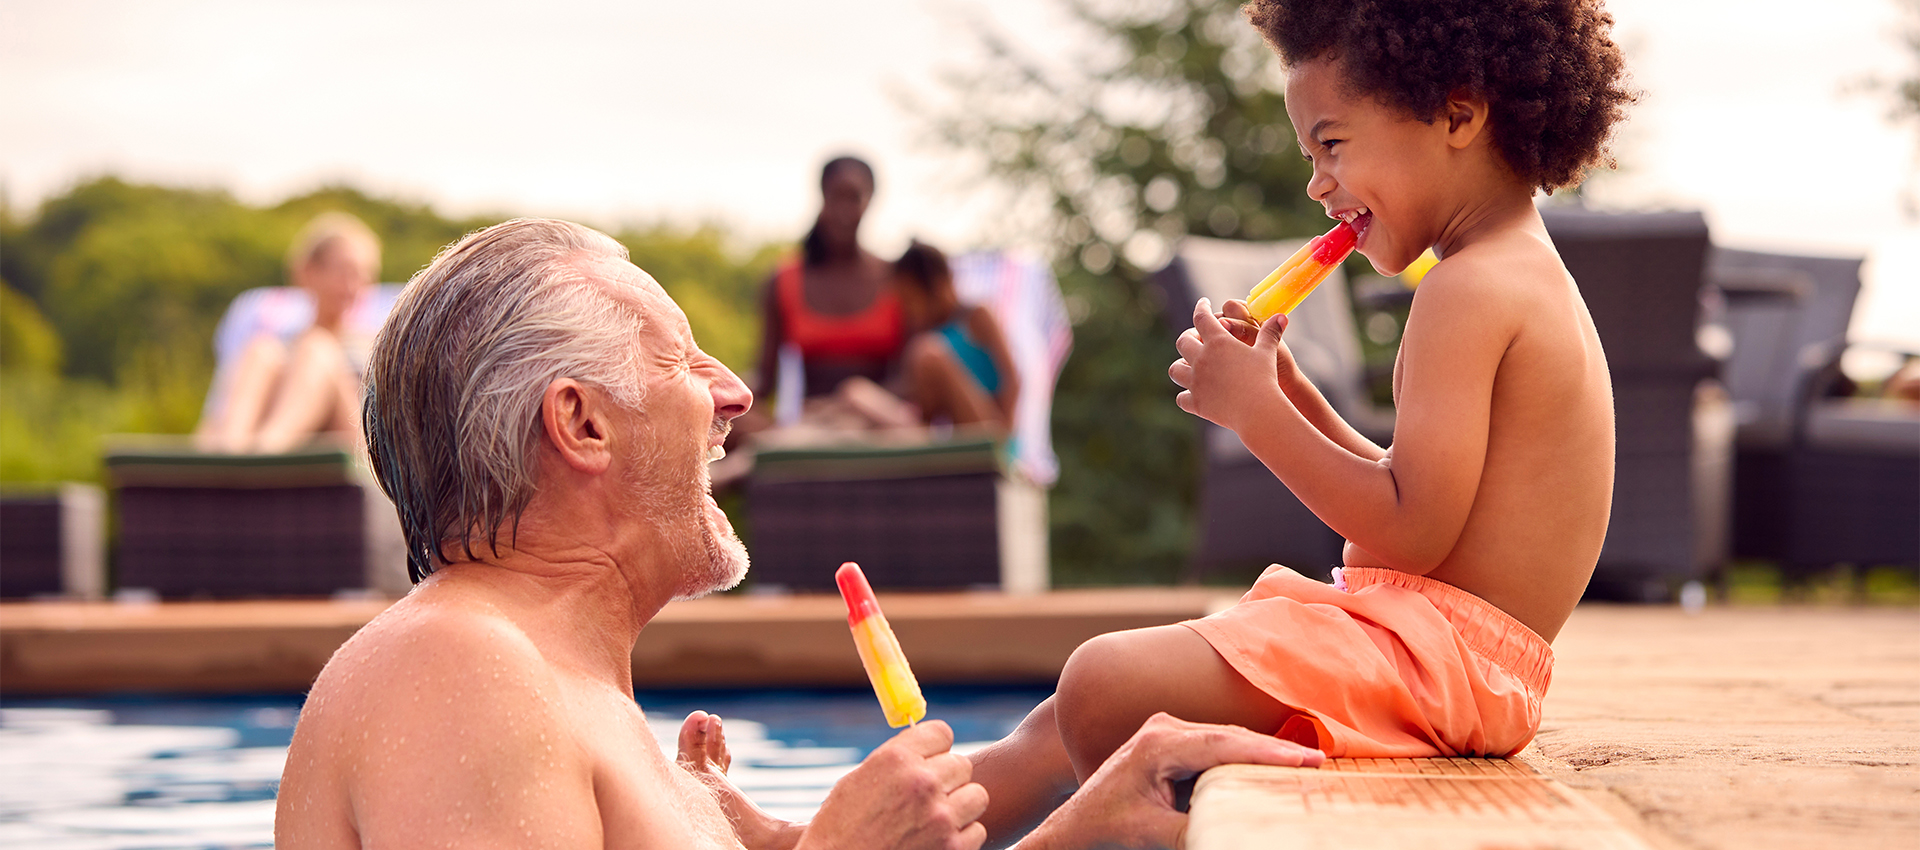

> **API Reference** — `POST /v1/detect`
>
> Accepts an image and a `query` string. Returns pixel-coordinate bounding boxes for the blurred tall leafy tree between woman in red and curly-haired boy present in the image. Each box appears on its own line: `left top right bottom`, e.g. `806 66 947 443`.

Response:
920 0 1327 585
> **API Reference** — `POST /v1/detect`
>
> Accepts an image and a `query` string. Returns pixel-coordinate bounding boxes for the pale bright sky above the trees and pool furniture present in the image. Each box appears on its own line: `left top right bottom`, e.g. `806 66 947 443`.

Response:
0 0 1920 345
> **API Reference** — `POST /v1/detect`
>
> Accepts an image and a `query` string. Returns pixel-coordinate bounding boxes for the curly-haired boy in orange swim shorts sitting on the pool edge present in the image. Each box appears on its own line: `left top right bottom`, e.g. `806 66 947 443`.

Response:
973 0 1632 837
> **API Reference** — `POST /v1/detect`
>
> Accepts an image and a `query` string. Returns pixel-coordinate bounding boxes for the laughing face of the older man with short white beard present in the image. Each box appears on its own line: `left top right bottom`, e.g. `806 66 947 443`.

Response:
595 259 753 599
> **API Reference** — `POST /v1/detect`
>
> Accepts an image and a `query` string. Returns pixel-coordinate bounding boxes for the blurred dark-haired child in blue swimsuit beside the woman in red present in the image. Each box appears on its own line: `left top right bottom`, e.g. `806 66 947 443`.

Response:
893 240 1020 434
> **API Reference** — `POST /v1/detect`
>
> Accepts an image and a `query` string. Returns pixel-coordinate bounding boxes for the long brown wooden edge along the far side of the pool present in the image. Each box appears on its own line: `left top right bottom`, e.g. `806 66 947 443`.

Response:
0 587 1235 697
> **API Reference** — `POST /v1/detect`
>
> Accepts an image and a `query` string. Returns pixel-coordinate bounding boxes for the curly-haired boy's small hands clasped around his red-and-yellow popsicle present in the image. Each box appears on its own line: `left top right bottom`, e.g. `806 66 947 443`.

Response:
1167 297 1286 432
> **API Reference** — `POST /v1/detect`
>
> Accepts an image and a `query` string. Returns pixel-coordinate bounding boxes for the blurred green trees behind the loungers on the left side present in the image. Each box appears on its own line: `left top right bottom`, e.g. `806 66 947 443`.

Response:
0 177 780 484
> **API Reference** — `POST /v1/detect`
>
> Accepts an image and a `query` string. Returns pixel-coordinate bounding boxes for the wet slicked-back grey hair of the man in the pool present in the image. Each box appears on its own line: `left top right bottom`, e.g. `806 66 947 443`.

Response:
361 219 641 581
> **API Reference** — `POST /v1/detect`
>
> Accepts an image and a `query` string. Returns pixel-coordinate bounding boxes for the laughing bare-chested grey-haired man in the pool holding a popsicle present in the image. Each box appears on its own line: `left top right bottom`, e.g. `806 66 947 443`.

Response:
275 221 1317 850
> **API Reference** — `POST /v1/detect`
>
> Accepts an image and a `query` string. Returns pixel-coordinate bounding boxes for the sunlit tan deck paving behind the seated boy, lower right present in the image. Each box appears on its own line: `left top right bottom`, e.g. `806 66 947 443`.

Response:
1521 606 1920 850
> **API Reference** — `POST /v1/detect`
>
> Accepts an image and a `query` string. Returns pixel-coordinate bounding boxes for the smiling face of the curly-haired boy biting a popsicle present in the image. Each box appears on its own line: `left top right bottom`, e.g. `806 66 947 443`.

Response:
1286 59 1448 274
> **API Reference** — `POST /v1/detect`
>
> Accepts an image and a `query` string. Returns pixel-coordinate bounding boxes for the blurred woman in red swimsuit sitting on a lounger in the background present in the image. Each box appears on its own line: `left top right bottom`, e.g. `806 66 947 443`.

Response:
753 157 906 416
